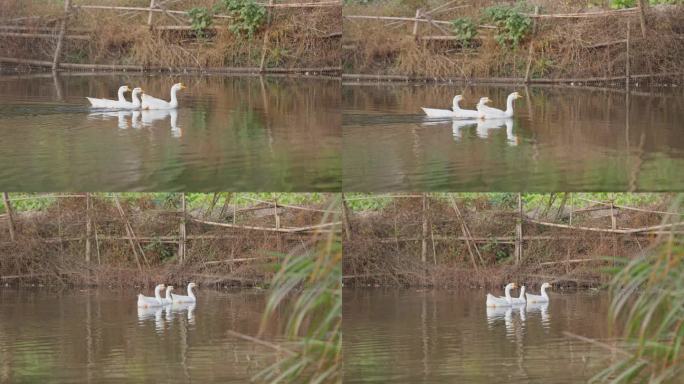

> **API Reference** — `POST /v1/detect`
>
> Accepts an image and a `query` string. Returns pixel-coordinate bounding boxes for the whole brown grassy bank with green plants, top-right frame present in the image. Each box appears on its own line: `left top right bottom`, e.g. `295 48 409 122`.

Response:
342 0 684 82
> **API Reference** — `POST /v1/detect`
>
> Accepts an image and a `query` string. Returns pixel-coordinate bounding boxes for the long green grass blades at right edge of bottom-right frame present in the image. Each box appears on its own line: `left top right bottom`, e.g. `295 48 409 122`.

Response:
594 194 684 383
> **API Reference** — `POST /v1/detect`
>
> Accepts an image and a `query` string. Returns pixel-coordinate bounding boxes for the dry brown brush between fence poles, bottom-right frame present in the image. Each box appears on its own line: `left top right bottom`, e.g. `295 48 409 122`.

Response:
343 198 667 287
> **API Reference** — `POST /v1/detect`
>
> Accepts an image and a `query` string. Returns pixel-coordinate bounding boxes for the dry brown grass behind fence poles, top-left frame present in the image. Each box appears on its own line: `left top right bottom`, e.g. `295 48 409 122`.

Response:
0 0 342 68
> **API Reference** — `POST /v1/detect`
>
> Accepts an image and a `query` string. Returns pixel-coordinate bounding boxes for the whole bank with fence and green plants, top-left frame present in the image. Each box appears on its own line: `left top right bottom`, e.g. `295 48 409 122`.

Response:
0 0 342 70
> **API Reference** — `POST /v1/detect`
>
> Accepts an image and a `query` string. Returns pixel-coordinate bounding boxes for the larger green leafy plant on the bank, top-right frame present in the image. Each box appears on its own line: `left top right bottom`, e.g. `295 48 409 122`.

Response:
484 5 532 49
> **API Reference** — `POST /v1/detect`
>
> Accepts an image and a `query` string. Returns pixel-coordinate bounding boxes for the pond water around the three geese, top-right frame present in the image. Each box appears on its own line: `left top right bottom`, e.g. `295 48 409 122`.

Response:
342 83 684 192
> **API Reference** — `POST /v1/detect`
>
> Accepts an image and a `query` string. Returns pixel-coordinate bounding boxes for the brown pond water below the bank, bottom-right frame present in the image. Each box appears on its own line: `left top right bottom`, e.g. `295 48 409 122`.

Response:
343 288 610 383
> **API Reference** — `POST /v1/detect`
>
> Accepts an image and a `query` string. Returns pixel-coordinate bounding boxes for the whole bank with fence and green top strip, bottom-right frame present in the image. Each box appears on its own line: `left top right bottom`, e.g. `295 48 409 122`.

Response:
343 193 677 287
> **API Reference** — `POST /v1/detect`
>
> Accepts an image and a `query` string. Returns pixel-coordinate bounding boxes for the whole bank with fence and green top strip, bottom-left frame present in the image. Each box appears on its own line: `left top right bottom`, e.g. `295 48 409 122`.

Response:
0 193 340 286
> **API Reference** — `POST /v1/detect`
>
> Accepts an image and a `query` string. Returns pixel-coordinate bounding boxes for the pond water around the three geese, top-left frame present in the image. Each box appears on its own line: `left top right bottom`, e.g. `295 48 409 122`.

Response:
0 73 341 192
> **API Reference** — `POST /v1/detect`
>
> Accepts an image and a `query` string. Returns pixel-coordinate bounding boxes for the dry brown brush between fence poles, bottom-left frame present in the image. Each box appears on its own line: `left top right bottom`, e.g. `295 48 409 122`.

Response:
0 197 322 286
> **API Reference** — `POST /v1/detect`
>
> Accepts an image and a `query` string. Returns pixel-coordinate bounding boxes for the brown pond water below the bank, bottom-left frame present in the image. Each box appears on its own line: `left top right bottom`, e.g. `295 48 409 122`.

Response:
0 288 284 383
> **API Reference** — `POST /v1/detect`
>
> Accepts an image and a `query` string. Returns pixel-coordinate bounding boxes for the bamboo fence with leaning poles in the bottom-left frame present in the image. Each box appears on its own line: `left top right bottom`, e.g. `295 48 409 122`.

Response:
0 192 341 272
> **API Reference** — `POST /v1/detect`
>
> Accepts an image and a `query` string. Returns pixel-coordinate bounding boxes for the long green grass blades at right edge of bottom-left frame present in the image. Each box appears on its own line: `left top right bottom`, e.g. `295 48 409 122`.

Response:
256 197 342 383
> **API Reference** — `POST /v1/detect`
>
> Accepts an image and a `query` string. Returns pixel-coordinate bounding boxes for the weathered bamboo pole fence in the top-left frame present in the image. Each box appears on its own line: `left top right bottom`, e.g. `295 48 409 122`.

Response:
0 0 342 74
